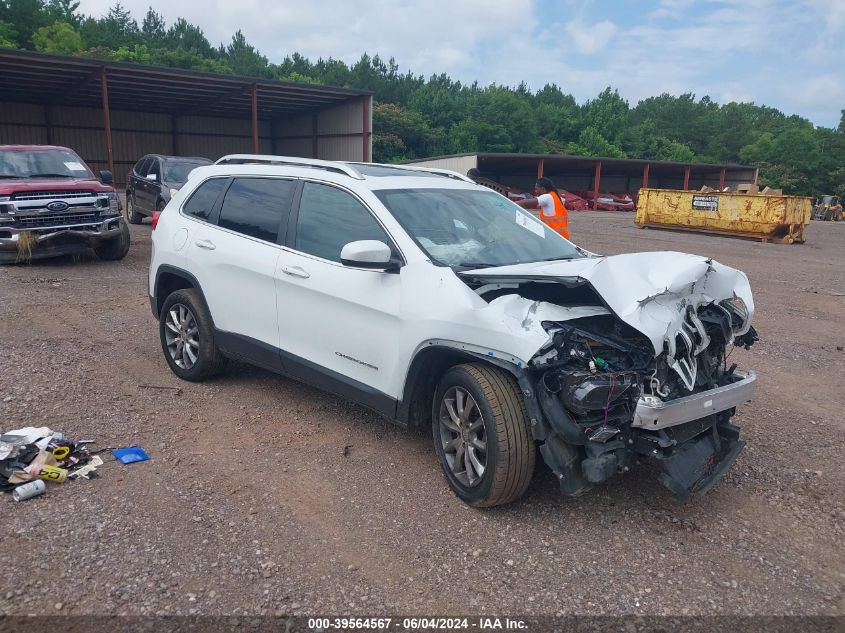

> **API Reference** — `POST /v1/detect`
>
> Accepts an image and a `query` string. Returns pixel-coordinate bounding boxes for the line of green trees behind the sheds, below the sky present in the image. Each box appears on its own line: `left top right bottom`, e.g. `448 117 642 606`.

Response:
0 0 845 195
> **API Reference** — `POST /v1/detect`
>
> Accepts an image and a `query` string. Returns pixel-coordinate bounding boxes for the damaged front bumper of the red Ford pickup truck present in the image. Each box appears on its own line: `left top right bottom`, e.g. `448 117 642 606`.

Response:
0 215 123 264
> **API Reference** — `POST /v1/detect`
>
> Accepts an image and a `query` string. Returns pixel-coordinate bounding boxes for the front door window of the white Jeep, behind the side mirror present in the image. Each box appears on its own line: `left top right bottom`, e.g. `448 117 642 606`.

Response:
294 182 392 262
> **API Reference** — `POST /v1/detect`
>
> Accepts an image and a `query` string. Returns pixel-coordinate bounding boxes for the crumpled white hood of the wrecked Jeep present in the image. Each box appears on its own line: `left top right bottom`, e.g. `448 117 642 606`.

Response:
460 251 754 355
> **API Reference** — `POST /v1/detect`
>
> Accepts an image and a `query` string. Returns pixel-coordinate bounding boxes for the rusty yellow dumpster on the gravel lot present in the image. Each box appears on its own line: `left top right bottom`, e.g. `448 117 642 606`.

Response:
635 189 813 244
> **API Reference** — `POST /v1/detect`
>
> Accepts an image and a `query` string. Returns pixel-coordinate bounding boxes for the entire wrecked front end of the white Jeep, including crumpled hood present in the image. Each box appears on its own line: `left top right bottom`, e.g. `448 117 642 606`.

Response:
462 254 757 501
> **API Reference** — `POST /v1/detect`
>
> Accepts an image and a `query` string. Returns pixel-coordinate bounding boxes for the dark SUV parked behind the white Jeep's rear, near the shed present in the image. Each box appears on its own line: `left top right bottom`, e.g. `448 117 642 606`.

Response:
126 154 211 224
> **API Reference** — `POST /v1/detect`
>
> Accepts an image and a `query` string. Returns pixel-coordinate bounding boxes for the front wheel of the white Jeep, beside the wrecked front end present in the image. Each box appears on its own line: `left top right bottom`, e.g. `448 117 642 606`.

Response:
432 363 535 508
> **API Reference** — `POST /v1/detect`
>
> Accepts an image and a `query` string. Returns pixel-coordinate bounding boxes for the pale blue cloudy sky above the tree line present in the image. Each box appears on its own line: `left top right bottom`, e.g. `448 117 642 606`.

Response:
80 0 845 127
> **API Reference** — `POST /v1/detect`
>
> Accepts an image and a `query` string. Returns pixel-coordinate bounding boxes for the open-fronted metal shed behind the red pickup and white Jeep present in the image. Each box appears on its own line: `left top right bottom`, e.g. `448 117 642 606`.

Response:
0 49 372 184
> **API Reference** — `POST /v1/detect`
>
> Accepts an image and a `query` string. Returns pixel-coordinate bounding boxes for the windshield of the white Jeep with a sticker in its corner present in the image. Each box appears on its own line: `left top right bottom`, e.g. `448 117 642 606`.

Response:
374 189 581 270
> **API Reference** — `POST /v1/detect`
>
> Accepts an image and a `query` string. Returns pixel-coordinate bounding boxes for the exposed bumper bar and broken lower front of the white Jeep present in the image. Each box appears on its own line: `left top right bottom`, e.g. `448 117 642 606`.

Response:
520 371 757 502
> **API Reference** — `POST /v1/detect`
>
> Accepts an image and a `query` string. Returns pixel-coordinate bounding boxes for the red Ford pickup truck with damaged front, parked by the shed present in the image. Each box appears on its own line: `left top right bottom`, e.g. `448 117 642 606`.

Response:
0 145 129 263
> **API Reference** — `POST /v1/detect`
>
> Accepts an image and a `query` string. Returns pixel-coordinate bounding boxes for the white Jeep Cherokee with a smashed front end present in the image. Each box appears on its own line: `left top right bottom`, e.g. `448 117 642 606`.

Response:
149 155 757 506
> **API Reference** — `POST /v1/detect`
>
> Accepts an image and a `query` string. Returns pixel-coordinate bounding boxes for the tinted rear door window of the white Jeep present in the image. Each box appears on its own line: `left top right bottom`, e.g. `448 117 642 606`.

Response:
217 178 295 242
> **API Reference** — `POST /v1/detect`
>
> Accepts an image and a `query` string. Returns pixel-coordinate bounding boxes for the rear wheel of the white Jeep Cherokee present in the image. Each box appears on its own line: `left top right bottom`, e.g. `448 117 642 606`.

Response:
159 288 227 382
